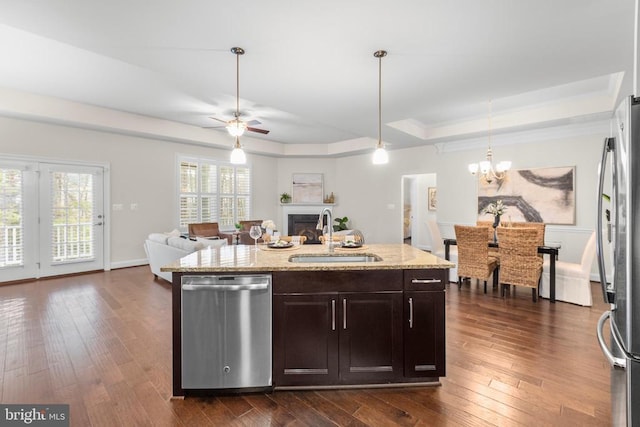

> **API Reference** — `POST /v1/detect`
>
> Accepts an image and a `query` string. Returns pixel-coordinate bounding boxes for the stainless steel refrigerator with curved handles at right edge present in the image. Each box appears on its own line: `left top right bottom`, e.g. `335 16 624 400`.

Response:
596 96 640 426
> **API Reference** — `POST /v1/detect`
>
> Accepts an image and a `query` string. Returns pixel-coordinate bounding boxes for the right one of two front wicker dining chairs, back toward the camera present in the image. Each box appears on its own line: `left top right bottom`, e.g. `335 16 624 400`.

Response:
498 227 542 302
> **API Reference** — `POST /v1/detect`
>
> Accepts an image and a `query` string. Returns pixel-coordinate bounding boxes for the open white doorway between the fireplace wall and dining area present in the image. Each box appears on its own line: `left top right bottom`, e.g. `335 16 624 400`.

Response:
401 173 436 250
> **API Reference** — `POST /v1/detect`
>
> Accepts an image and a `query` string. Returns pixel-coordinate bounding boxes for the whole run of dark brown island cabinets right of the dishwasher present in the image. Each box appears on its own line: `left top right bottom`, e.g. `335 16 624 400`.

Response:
273 270 447 387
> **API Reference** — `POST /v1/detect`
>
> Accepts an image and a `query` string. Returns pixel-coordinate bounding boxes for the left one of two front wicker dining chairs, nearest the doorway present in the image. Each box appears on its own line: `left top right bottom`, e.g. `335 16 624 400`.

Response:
454 225 499 293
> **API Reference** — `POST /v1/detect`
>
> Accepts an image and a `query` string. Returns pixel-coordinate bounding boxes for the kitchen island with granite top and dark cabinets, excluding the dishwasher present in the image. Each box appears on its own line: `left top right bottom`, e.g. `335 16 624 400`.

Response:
162 244 454 396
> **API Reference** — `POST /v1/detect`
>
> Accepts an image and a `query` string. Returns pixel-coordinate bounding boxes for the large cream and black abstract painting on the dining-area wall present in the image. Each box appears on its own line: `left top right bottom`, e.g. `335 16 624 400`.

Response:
478 166 576 224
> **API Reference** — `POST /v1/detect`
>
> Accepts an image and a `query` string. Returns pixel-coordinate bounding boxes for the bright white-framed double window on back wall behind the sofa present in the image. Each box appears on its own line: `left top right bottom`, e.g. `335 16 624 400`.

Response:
178 158 251 230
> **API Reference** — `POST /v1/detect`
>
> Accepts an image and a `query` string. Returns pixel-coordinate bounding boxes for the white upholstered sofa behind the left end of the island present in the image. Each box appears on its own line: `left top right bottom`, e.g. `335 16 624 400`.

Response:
144 230 227 282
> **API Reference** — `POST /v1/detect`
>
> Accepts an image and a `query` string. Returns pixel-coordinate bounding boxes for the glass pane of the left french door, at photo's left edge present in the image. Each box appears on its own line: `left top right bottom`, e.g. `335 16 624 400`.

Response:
0 168 24 268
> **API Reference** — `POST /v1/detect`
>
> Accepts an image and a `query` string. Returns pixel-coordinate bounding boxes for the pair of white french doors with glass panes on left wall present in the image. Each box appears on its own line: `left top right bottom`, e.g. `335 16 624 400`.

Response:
0 161 104 282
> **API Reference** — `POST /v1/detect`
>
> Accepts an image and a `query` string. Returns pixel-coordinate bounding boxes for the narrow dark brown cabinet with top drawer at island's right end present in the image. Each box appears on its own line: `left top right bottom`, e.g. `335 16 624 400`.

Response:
404 270 447 378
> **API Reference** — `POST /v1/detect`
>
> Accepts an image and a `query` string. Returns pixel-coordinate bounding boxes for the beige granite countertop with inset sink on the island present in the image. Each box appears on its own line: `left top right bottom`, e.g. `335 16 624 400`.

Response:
161 244 455 273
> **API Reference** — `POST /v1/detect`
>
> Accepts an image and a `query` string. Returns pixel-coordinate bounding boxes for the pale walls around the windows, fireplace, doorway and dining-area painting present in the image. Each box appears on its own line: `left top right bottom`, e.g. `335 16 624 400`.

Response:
0 113 609 278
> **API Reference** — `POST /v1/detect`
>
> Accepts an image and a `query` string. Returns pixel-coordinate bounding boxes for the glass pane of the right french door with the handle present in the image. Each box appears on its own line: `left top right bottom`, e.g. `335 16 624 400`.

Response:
51 172 95 262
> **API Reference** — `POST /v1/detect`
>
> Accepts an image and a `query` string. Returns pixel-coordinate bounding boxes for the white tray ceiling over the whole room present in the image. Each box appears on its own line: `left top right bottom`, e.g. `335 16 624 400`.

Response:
0 0 634 155
